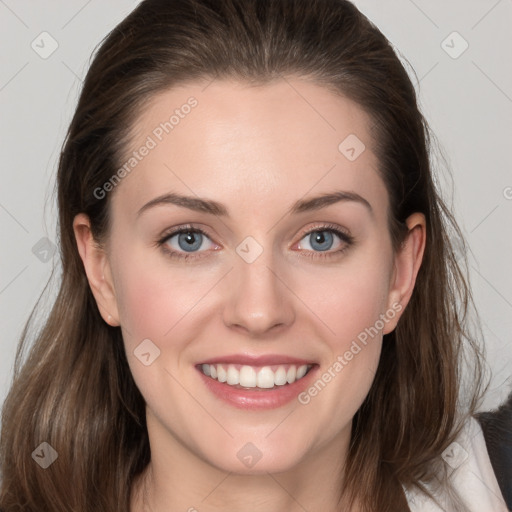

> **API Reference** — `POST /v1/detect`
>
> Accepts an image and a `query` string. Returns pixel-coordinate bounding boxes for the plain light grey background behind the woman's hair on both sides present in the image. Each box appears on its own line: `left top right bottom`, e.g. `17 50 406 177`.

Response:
0 0 512 409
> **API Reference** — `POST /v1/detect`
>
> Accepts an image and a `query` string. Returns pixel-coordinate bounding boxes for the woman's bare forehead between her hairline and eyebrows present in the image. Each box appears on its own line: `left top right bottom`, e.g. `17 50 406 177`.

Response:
113 78 387 220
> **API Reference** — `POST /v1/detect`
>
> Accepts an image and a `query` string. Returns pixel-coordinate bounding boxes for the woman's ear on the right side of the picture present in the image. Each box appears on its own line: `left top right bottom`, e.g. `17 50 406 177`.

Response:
382 213 426 334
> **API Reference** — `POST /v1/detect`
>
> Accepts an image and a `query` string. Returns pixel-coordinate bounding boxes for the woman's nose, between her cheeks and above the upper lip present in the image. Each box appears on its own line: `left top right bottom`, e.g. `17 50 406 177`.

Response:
224 250 295 337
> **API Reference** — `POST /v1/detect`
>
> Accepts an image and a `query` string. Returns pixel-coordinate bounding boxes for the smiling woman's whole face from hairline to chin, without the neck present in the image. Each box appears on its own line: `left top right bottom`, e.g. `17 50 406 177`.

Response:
79 78 420 473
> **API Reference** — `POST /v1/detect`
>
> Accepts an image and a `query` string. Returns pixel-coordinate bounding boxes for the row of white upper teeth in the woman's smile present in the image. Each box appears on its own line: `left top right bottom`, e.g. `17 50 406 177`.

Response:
201 364 311 389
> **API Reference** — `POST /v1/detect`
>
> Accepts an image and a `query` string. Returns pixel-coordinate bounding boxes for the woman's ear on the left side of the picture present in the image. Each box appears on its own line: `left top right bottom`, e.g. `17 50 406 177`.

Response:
73 213 119 326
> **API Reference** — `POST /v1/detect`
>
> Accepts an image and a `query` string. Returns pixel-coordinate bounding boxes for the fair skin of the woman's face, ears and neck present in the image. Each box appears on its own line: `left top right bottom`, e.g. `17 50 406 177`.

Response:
74 77 425 512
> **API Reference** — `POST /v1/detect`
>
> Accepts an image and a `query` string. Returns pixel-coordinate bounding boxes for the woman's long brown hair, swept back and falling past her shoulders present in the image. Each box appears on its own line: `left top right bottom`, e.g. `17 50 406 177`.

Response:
0 0 483 512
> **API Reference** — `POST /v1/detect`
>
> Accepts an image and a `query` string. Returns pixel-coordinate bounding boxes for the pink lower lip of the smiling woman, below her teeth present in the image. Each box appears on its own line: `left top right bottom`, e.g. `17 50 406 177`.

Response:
197 365 319 410
